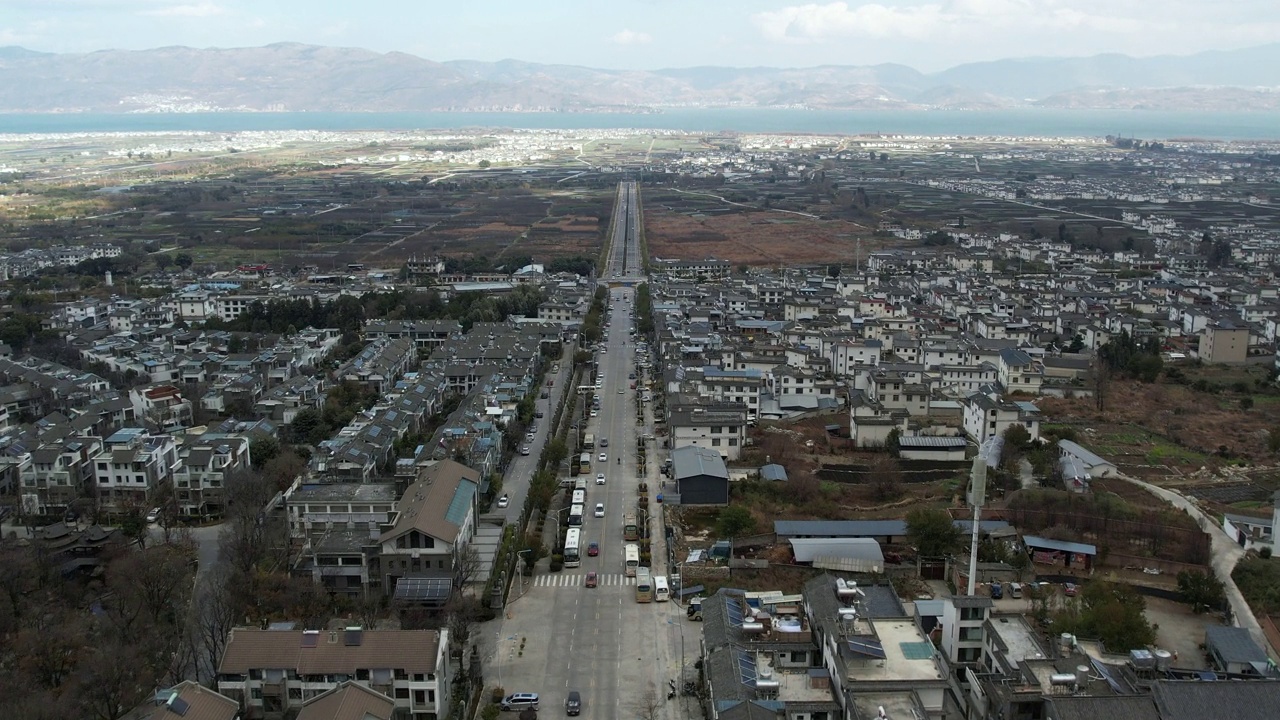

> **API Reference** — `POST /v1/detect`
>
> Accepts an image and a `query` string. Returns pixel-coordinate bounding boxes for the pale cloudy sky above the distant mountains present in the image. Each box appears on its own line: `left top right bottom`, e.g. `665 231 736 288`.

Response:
0 0 1280 72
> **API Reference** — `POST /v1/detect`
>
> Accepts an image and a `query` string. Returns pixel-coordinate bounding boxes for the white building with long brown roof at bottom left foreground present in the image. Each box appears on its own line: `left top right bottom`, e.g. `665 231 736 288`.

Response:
218 628 451 720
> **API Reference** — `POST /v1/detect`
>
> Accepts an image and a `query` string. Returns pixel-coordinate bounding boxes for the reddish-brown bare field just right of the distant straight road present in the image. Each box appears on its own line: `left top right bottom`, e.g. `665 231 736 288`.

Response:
644 204 900 266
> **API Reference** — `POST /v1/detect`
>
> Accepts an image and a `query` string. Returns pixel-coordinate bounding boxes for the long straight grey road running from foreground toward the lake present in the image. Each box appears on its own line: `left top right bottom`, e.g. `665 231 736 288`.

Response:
486 183 698 717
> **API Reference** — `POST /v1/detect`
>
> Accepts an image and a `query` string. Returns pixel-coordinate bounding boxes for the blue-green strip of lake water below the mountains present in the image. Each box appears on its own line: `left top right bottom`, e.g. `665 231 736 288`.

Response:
0 109 1280 141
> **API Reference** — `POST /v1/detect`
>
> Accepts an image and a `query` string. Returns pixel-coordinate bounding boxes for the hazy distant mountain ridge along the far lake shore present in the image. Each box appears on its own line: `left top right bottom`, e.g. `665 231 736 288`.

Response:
0 42 1280 113
